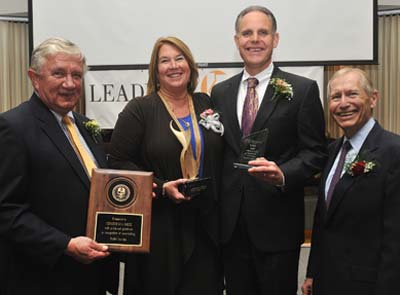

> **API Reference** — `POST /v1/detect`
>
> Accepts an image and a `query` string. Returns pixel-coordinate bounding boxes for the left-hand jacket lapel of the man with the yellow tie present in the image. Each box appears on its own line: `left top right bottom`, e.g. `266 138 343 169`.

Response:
30 95 90 188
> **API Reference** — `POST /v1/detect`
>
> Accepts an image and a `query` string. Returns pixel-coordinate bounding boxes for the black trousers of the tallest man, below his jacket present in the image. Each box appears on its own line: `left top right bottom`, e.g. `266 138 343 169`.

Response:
222 217 300 295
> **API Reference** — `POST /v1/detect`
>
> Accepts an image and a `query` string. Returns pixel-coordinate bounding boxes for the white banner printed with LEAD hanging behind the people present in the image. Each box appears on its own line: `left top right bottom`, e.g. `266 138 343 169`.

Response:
85 67 324 129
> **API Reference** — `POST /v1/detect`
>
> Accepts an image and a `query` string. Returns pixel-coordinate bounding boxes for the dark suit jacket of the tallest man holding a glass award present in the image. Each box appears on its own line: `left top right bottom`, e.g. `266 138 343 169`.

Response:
211 68 326 252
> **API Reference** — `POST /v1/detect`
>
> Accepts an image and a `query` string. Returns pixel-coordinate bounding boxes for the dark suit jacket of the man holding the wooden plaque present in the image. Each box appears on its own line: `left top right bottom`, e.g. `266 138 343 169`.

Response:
0 94 118 295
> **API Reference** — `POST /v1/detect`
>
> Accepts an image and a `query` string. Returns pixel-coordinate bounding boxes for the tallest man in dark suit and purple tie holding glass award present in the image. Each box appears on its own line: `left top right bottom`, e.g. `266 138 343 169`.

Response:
211 6 326 295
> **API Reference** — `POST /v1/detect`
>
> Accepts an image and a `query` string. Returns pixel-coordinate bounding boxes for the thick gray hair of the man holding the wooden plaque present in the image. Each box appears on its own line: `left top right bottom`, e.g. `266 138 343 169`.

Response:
30 37 87 72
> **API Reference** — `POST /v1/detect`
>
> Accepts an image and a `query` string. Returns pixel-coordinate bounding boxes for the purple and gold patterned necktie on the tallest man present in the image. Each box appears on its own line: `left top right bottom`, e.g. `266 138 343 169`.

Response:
242 78 258 137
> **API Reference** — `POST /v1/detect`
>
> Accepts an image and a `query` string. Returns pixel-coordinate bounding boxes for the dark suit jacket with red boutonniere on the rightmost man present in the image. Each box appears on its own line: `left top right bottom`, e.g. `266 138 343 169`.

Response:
307 123 400 295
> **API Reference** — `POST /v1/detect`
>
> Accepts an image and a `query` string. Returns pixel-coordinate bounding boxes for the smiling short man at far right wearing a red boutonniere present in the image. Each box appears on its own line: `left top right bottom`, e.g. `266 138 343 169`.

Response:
303 68 400 295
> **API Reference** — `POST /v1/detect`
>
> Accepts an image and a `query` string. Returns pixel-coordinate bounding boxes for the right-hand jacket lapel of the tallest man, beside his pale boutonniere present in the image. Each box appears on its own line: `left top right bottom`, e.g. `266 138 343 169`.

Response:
251 67 284 132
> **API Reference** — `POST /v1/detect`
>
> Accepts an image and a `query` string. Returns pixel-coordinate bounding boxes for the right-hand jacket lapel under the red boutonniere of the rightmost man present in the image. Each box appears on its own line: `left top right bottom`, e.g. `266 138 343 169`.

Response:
326 123 383 221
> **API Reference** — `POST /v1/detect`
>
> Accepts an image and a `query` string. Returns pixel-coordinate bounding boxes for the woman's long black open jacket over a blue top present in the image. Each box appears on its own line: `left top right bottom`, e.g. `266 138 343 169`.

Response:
109 93 223 294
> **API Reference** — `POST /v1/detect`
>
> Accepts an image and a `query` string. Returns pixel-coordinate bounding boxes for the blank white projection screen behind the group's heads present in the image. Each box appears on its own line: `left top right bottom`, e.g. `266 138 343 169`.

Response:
33 0 376 66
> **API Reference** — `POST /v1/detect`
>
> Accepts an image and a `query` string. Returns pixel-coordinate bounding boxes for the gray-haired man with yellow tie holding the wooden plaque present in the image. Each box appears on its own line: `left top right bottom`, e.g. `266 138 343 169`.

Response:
0 38 118 295
